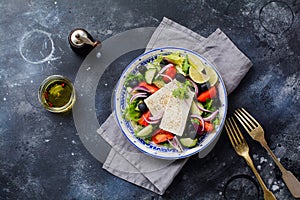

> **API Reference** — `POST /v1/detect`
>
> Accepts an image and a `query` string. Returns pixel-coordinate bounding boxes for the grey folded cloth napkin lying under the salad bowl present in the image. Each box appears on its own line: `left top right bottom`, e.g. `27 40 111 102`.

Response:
98 18 252 194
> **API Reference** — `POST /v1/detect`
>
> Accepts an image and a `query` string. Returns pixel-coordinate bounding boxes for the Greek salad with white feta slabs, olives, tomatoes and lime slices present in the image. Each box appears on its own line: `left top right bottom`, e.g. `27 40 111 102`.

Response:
123 52 220 152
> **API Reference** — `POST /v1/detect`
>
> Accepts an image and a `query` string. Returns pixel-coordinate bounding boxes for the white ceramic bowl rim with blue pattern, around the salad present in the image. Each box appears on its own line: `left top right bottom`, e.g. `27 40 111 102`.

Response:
113 47 227 159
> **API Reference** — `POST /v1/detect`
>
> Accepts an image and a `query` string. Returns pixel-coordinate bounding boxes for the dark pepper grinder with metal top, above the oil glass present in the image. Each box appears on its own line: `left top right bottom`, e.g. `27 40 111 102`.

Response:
68 28 101 56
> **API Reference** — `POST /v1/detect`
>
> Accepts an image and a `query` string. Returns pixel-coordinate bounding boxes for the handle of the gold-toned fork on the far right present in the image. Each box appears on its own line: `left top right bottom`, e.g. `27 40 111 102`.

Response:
261 141 300 198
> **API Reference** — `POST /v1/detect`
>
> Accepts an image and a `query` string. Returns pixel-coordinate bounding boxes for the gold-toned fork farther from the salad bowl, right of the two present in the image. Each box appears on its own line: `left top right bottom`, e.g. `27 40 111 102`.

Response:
234 108 300 198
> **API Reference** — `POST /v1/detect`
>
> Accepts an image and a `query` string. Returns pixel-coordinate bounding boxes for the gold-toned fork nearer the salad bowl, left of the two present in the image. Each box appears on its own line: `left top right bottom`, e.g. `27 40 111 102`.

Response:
225 118 276 200
